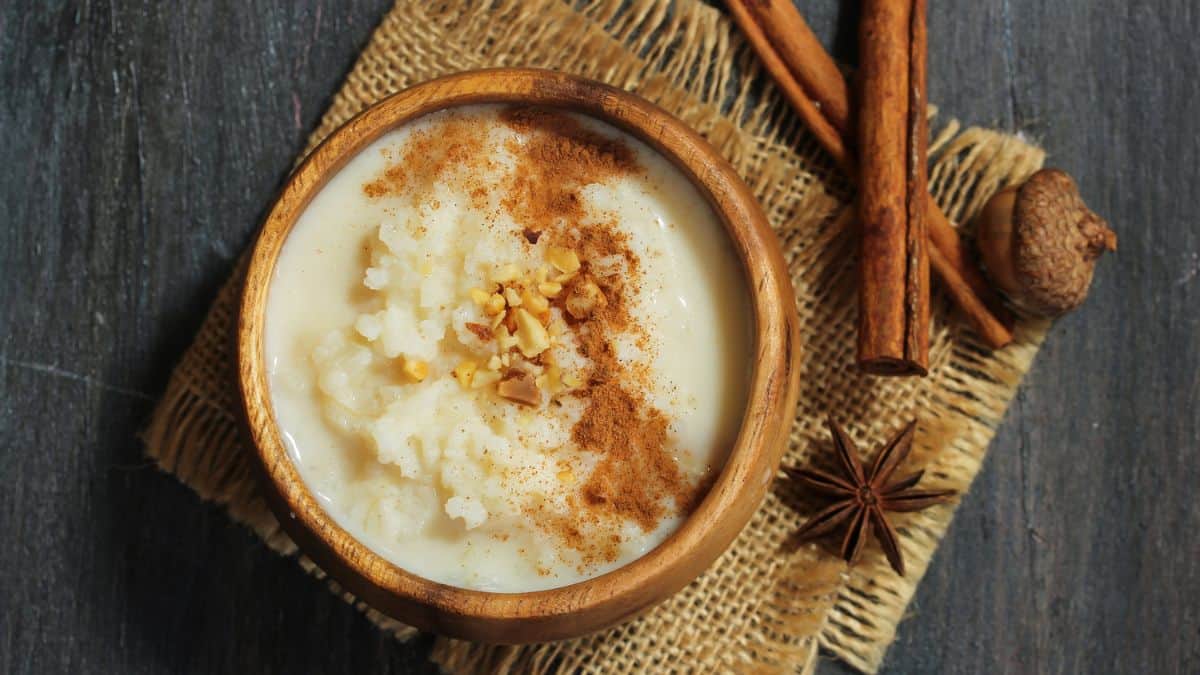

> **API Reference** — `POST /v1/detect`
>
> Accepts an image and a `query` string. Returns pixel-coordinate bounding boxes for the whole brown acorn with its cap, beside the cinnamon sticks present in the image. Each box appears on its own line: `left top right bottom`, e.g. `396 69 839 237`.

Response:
976 168 1117 317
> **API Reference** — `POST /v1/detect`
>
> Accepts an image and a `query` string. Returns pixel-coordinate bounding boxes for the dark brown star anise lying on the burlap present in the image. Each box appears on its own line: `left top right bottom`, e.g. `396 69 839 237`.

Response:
784 417 954 577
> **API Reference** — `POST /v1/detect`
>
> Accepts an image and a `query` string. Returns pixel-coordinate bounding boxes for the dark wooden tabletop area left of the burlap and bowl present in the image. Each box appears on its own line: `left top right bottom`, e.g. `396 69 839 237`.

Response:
0 0 432 673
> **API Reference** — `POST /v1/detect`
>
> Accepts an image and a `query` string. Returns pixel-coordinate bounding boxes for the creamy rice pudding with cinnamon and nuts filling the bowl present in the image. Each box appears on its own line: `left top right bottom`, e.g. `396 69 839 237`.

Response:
265 106 752 592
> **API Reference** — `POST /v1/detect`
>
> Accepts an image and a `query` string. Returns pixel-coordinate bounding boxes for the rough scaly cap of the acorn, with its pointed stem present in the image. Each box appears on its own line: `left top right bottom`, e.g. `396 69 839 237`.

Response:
1012 169 1117 316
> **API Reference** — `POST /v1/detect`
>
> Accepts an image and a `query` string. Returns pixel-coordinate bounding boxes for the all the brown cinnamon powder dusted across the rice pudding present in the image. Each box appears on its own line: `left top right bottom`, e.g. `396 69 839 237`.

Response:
362 107 708 566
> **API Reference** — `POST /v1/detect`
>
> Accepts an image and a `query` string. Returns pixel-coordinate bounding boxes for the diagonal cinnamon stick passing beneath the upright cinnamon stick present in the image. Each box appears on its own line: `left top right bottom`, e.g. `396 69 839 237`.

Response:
726 0 1013 348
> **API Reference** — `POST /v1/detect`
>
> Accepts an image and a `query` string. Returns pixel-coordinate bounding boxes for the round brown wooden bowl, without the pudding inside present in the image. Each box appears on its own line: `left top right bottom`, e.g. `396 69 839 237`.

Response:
238 68 799 643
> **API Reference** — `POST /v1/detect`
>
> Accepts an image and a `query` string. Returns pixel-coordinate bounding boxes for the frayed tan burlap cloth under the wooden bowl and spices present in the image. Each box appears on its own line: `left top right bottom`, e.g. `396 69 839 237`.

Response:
145 0 1046 673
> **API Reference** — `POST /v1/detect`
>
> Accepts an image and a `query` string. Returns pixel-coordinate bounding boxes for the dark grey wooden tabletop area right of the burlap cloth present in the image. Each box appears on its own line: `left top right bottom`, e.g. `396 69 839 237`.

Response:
840 0 1200 673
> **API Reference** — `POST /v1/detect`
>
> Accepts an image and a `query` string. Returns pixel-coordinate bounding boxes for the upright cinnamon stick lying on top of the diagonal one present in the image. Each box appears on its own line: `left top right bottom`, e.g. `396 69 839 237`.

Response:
858 0 929 375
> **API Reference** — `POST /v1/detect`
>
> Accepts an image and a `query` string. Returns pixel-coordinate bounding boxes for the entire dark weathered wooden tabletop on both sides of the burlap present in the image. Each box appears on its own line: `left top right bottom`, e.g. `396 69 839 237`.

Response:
0 0 1200 674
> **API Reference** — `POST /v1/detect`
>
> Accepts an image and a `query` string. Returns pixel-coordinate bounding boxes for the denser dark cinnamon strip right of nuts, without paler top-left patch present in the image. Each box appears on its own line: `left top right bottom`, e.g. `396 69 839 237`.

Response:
500 108 696 552
